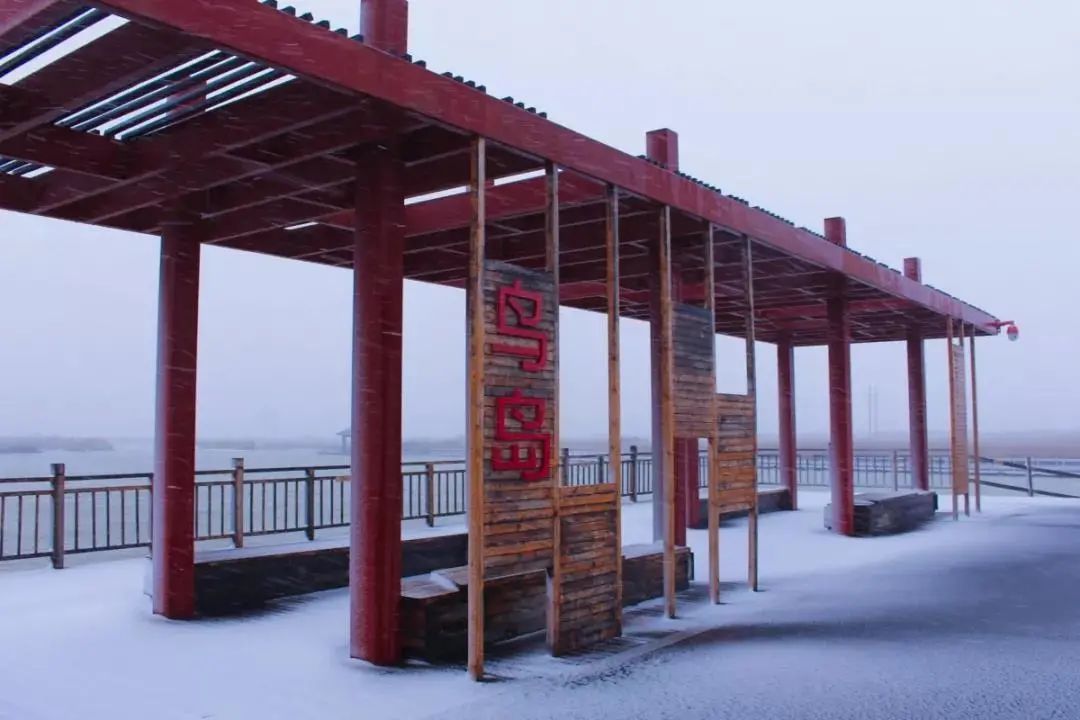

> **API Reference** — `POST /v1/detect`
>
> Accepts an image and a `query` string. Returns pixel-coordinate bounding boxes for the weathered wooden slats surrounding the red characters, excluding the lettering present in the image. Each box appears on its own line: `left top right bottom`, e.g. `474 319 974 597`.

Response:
483 260 557 579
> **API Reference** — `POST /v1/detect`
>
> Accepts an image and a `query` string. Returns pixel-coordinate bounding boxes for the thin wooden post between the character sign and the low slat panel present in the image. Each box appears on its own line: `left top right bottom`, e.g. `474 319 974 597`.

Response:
544 162 566 654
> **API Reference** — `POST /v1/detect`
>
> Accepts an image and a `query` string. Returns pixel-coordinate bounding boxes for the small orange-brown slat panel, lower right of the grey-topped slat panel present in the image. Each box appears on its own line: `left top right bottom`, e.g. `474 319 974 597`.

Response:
708 394 757 512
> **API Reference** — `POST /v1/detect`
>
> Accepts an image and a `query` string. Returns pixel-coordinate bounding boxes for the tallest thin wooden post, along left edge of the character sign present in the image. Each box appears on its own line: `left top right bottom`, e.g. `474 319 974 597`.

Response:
465 137 487 680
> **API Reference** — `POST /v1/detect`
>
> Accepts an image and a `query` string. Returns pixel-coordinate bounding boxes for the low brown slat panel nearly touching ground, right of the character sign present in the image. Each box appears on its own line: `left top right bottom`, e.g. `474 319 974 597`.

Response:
553 483 621 654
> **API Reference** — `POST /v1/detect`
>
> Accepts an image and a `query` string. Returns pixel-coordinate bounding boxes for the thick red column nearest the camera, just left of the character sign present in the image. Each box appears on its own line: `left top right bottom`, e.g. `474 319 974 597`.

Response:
349 134 405 665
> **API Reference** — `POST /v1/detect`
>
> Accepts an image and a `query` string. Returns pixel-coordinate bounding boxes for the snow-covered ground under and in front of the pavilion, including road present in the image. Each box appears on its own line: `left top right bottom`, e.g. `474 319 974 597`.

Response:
0 491 1080 720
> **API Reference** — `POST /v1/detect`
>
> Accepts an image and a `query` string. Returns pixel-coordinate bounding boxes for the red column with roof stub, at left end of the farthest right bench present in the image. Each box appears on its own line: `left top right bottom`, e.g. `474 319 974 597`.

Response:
825 217 855 535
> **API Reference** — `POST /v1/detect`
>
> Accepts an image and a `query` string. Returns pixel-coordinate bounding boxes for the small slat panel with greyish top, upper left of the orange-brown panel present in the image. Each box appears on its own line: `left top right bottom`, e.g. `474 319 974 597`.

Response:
673 303 716 438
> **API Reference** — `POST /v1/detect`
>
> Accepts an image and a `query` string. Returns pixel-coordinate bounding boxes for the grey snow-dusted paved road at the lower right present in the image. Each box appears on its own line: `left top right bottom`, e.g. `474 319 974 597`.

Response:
438 504 1080 720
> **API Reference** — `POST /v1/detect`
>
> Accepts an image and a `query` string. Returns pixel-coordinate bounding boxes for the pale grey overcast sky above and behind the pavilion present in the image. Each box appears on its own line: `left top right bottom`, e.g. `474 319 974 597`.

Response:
0 0 1080 437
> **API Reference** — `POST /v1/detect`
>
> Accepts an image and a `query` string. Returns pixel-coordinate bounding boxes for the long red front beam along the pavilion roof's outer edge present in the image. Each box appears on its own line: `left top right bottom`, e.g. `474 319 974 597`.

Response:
88 0 995 332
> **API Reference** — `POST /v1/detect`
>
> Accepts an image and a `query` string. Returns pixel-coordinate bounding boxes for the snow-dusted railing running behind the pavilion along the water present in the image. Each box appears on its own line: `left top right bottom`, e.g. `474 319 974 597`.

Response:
0 448 1080 568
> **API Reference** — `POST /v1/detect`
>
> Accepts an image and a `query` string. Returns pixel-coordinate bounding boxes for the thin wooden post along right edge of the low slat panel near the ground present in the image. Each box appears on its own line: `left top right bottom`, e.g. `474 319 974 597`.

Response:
605 185 622 635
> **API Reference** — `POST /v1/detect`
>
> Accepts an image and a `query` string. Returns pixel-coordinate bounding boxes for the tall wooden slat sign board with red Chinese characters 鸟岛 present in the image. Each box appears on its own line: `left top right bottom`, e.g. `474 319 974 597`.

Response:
484 260 558 579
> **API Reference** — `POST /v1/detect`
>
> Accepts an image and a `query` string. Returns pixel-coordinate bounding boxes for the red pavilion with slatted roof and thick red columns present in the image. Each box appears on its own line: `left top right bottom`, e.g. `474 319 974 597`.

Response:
0 0 1000 677
